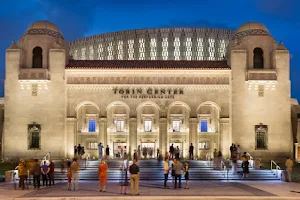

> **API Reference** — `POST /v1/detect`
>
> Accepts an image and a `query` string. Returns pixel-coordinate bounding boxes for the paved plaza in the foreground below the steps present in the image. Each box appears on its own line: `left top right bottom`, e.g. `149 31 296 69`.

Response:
0 181 300 200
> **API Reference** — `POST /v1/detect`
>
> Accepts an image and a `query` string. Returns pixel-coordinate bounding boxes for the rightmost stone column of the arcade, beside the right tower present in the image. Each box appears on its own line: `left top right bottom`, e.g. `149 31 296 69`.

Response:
217 118 232 158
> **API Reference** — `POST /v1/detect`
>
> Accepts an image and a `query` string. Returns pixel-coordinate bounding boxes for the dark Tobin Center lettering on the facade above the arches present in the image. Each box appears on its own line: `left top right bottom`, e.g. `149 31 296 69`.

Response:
113 87 183 99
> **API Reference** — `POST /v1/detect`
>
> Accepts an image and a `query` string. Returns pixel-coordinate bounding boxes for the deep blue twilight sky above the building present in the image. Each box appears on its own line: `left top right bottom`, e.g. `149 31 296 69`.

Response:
0 0 300 100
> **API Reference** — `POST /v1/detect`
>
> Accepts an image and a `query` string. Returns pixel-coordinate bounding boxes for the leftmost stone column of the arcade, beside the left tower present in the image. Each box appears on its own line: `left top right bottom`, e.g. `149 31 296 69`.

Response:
65 118 77 158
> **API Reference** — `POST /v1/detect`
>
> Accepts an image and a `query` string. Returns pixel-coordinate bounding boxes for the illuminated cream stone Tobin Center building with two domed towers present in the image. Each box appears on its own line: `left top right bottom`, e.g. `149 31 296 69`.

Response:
2 21 297 159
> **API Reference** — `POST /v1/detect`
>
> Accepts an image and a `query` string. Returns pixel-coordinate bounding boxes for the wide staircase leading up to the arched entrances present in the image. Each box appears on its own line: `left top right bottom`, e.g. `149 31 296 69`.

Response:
54 160 281 181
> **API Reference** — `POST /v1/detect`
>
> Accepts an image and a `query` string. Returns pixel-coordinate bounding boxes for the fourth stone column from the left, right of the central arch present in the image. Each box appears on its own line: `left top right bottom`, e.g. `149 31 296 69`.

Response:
159 118 169 157
